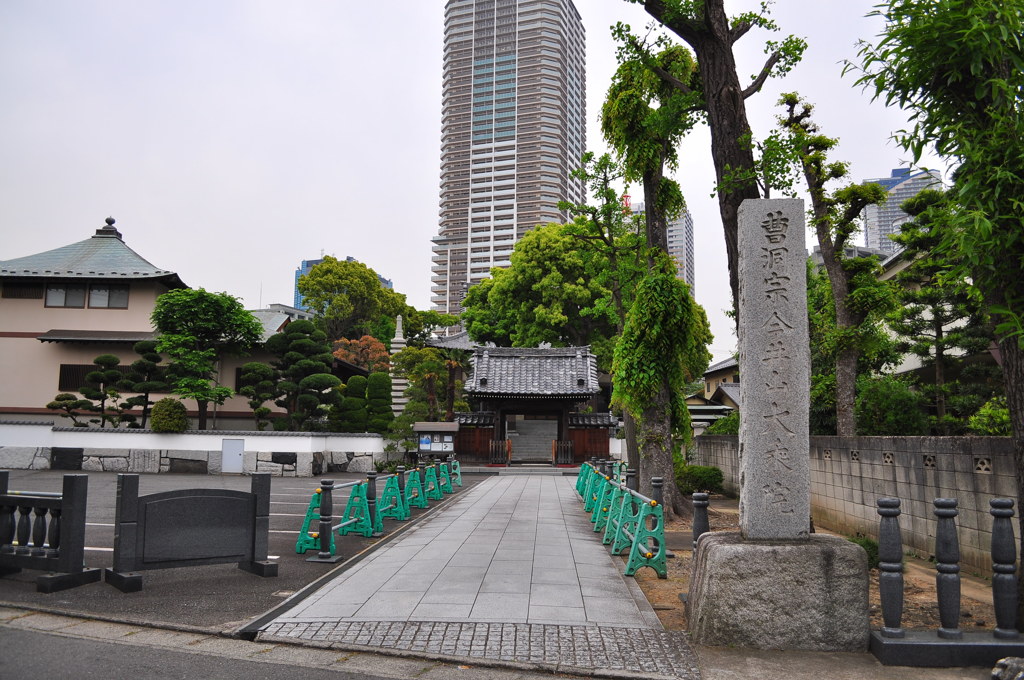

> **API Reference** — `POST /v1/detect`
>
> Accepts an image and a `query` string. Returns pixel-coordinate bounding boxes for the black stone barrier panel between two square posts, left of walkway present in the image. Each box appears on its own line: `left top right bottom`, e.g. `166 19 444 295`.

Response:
106 474 278 593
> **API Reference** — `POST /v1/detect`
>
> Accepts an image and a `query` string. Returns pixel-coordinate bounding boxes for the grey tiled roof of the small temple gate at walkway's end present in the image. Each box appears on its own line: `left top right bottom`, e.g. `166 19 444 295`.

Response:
466 346 600 399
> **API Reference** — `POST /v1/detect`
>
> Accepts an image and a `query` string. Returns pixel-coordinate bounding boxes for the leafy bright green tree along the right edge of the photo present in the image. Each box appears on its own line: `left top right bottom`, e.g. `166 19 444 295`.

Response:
858 0 1024 617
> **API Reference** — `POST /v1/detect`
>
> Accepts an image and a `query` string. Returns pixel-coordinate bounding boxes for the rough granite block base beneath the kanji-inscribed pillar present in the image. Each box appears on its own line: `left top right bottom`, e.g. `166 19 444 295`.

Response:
686 532 868 651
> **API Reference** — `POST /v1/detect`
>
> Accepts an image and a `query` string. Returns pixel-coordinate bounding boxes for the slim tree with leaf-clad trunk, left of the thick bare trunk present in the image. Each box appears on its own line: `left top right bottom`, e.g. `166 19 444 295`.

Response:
601 38 711 516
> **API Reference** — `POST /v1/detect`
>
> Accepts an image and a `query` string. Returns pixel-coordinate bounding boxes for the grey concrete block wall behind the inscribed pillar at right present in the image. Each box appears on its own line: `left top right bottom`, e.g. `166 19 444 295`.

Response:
690 435 1020 575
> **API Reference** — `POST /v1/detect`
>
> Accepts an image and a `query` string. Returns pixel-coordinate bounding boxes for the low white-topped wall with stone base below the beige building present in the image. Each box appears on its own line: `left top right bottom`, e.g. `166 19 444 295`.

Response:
0 422 385 477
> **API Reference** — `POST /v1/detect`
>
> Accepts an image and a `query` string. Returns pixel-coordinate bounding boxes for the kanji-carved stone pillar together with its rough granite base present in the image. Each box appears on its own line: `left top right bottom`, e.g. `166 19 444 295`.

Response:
686 199 868 651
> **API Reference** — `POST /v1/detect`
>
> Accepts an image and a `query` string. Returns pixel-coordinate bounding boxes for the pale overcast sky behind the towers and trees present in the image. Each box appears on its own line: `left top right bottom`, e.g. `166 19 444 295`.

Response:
0 0 937 359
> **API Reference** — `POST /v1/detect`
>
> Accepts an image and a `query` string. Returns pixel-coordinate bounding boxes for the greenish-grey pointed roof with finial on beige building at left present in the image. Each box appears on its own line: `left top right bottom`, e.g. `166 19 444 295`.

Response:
0 218 184 288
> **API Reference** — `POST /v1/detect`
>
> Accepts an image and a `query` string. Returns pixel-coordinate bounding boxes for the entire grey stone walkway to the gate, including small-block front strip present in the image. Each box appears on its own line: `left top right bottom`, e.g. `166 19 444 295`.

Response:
260 475 699 678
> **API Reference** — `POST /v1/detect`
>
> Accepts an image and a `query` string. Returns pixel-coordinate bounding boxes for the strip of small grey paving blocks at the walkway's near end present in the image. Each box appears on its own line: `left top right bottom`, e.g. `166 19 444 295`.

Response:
258 621 700 680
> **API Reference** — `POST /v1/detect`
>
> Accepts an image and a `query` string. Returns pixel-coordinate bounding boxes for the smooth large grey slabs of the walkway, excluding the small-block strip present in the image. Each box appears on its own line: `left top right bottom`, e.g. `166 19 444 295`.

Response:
274 476 662 628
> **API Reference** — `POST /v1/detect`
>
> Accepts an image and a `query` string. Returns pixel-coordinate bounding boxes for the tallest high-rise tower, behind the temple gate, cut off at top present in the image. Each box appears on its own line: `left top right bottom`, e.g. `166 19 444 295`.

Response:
430 0 586 314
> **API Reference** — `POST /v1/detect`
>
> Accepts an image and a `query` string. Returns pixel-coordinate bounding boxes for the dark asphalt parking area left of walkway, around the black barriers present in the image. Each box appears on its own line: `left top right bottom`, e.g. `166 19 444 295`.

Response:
0 470 482 632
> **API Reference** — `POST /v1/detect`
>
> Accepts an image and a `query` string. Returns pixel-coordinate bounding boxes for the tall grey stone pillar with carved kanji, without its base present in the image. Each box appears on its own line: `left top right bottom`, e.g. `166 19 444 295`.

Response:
739 199 811 540
